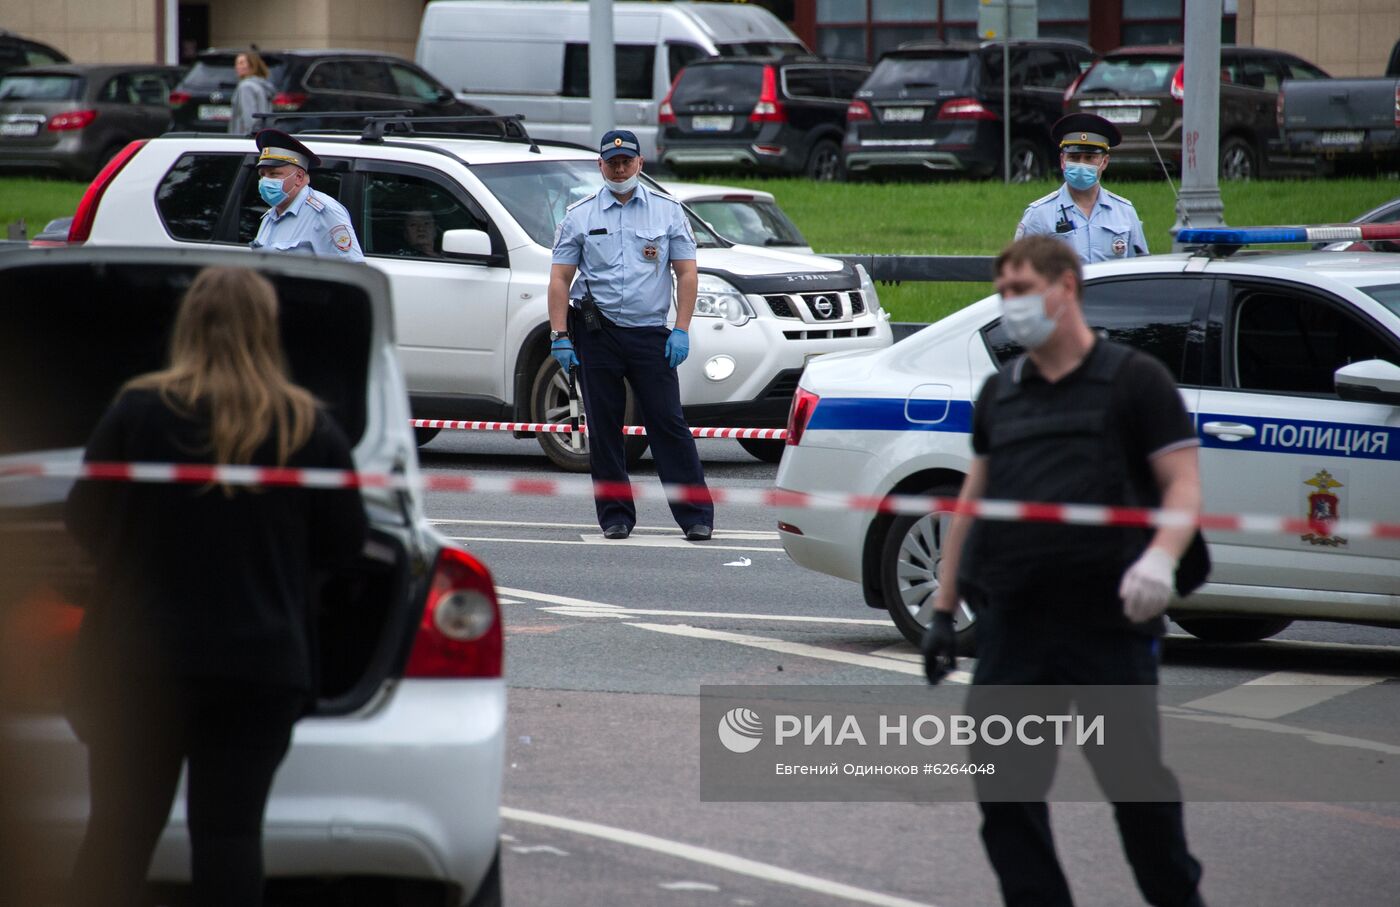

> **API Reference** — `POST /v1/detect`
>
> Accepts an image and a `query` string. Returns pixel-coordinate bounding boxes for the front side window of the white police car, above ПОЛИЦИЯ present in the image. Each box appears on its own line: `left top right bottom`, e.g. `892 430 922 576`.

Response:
1228 287 1400 396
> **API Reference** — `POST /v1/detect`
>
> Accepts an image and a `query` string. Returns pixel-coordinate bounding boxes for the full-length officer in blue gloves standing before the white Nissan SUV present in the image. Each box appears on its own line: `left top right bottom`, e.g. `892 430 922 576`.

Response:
549 130 714 542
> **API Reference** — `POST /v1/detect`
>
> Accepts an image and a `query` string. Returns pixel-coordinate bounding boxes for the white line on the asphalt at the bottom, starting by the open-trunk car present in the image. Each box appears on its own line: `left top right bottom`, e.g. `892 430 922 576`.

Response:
501 806 934 907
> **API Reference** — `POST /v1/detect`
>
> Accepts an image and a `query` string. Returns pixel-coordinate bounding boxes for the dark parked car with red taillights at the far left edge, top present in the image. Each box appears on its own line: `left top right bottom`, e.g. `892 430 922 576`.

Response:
0 63 185 179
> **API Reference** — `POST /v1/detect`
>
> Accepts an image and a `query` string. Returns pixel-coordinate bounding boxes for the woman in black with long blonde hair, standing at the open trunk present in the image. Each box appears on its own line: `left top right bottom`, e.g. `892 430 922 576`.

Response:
66 267 367 907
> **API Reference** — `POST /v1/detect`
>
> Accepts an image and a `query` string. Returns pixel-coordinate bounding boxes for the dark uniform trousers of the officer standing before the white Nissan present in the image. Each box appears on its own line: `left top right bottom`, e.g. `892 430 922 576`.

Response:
570 318 714 529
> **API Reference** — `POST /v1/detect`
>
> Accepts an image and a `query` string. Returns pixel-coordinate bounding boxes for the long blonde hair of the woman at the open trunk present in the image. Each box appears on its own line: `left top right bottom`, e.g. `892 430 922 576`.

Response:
123 267 316 466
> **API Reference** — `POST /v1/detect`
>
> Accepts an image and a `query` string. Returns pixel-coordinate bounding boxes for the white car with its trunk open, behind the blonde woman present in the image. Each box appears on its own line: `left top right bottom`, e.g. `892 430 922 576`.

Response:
0 245 505 907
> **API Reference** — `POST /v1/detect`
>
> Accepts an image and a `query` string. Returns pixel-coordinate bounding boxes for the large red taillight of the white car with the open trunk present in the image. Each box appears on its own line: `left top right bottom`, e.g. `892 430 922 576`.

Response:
403 547 504 677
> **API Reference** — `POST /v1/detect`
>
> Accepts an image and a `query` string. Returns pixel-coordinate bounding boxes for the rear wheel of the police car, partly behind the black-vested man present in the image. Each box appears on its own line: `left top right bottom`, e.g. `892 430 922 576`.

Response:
879 484 977 655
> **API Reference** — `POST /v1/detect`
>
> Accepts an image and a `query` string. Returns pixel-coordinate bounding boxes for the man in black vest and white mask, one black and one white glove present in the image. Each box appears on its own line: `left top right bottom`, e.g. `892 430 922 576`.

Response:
924 237 1208 907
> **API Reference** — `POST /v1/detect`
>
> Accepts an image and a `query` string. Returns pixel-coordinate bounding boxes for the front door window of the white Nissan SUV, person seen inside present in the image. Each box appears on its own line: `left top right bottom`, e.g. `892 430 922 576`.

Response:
360 172 486 260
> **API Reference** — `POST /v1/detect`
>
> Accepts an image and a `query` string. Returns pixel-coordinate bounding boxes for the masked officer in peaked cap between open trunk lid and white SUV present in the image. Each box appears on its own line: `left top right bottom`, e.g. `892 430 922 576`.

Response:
249 129 364 262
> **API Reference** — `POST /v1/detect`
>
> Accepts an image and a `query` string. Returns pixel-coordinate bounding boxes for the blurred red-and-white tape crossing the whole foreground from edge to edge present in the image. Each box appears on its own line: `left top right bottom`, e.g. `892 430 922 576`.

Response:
0 462 1400 540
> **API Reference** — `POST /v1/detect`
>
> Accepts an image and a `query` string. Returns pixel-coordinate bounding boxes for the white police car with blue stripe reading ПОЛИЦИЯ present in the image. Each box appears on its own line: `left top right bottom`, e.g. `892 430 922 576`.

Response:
777 225 1400 642
